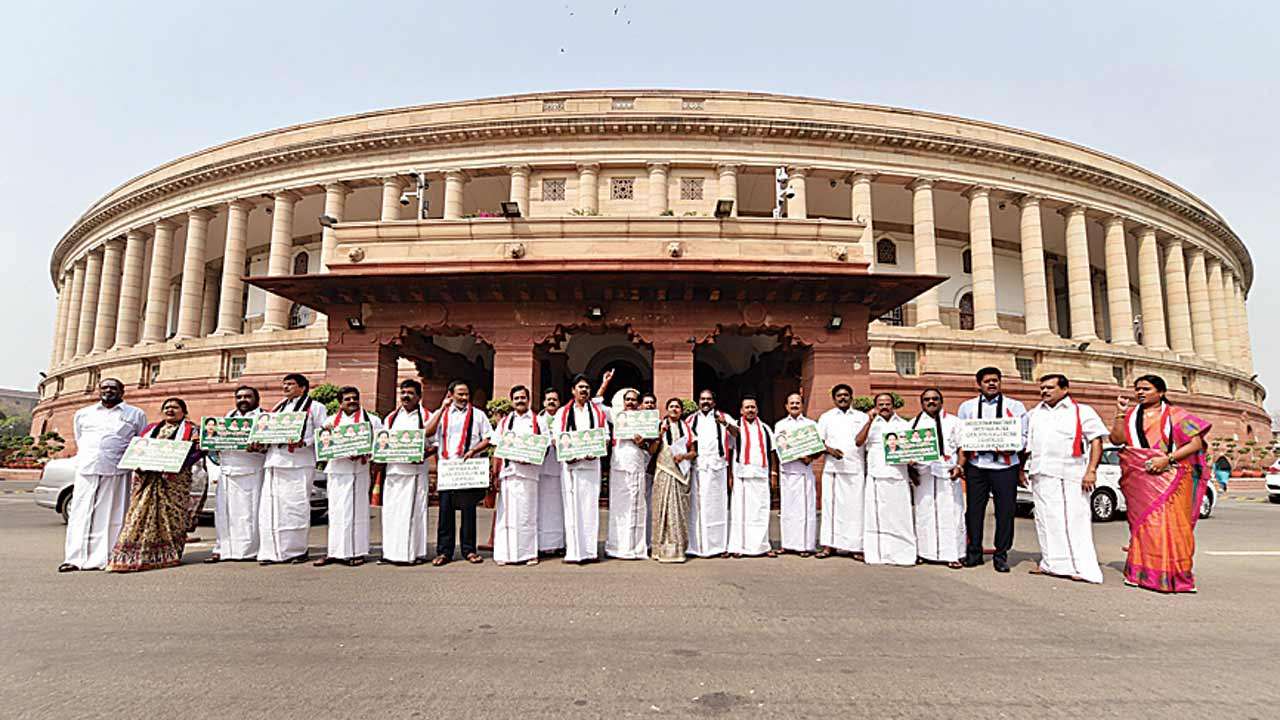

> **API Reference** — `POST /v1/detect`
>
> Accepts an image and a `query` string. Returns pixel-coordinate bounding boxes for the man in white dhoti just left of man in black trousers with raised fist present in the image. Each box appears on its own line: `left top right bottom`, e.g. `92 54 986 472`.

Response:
378 379 430 565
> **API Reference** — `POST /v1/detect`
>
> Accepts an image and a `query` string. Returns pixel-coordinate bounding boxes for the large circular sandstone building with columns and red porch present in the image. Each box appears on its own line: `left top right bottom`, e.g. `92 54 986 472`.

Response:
33 91 1270 448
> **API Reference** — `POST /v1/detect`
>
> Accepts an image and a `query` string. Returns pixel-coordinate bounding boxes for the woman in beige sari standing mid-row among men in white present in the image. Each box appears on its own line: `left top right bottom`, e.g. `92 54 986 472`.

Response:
650 397 698 562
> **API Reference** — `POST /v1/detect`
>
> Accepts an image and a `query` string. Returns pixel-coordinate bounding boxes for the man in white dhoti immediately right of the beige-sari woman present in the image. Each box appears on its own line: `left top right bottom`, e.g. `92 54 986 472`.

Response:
687 389 739 557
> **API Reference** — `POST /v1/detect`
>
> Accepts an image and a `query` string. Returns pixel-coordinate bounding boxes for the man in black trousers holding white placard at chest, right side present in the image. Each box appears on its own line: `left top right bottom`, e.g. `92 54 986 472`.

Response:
956 368 1027 573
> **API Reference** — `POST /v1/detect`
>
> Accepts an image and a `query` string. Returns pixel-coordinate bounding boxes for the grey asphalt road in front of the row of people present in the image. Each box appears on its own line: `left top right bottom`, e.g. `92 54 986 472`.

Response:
0 483 1280 720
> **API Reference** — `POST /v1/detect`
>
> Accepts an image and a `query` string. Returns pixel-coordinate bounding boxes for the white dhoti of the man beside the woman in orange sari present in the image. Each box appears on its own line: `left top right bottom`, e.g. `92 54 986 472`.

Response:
1030 474 1102 583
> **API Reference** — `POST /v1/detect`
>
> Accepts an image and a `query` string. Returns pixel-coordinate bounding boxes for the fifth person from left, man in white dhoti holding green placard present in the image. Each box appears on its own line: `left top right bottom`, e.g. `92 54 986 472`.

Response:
315 386 383 568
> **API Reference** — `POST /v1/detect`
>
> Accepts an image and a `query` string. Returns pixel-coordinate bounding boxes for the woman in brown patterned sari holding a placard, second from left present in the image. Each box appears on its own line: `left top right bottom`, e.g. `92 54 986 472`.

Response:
106 397 204 573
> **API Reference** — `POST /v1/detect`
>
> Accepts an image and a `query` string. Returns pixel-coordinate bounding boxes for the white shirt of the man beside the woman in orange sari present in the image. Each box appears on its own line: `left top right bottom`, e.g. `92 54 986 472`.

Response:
1023 396 1110 482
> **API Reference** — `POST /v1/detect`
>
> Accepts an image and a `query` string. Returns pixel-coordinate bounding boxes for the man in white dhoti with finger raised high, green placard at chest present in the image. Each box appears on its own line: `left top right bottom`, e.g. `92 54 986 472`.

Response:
556 372 612 564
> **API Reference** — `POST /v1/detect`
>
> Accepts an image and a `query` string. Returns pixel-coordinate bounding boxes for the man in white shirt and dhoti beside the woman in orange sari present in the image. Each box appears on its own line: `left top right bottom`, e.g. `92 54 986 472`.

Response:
1023 373 1110 583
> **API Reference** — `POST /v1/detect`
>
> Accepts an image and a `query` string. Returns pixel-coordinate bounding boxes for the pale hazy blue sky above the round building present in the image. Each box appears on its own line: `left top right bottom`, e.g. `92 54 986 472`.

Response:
0 0 1280 409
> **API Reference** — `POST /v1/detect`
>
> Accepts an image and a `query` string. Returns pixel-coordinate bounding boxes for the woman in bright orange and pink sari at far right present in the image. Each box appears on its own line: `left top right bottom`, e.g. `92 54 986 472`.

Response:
1111 375 1211 592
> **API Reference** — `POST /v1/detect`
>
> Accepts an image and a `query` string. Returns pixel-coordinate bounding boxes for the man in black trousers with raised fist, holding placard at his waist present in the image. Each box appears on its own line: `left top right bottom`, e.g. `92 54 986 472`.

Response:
425 380 493 566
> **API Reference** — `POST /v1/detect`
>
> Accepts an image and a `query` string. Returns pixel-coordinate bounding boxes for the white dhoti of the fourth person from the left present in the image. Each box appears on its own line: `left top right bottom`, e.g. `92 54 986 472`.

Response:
257 468 315 562
